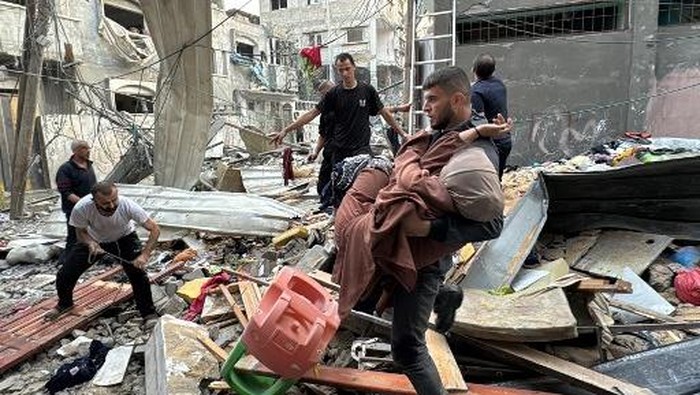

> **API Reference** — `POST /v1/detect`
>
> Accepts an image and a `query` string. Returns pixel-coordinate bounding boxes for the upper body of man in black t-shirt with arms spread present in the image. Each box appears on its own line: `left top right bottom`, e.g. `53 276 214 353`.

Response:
271 53 406 166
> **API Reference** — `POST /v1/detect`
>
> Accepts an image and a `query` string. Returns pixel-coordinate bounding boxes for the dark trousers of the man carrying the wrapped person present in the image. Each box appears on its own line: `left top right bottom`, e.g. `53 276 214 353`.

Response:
391 256 452 395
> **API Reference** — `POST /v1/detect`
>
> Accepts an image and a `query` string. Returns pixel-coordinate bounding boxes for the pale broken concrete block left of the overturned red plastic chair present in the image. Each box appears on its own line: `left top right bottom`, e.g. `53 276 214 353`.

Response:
145 315 219 395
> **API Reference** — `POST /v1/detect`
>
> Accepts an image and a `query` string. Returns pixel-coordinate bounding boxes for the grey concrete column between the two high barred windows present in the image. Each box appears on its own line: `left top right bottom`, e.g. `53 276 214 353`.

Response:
626 0 659 130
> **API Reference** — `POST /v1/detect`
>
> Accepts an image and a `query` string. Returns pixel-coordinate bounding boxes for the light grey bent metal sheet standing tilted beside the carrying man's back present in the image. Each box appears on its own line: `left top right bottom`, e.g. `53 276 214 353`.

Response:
460 179 548 290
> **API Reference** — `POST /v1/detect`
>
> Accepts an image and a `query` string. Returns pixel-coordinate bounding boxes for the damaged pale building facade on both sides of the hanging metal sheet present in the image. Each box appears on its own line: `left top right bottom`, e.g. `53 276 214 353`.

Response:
0 0 296 190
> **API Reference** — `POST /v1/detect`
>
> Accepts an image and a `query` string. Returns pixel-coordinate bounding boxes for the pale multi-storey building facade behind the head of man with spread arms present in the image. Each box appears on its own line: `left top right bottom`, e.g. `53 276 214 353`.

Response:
260 0 406 103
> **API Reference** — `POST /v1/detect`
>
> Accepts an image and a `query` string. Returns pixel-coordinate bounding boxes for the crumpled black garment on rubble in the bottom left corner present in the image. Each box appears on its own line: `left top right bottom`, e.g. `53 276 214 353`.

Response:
46 340 109 394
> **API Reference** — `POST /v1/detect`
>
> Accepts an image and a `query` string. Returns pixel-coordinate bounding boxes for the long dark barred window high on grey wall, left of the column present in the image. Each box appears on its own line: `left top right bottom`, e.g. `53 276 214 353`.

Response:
457 0 624 44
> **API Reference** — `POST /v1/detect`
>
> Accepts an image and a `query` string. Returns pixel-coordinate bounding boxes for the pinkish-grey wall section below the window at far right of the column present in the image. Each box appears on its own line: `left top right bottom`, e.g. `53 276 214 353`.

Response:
646 25 700 138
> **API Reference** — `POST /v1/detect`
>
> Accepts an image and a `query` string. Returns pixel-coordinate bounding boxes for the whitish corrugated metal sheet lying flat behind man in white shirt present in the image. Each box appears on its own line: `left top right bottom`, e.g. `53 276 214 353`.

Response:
41 185 303 237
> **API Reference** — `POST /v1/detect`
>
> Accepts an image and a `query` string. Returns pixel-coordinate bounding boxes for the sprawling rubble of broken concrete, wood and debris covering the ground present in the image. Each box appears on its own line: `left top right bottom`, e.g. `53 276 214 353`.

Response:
0 138 700 394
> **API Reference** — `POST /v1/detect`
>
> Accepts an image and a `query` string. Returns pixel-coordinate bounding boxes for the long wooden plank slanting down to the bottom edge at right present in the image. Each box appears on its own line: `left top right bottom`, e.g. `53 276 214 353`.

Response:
466 338 653 395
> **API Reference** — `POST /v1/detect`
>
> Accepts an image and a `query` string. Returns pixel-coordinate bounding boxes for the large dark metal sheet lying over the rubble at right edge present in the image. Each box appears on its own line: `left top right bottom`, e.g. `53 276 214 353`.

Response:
542 157 700 239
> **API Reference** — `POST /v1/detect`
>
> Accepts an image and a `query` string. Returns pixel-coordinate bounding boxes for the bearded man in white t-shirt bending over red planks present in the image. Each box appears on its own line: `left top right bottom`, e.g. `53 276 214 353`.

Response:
46 181 160 326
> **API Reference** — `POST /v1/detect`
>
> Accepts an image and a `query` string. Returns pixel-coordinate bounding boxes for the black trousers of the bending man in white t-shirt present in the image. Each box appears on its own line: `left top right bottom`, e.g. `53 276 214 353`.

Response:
56 232 155 317
